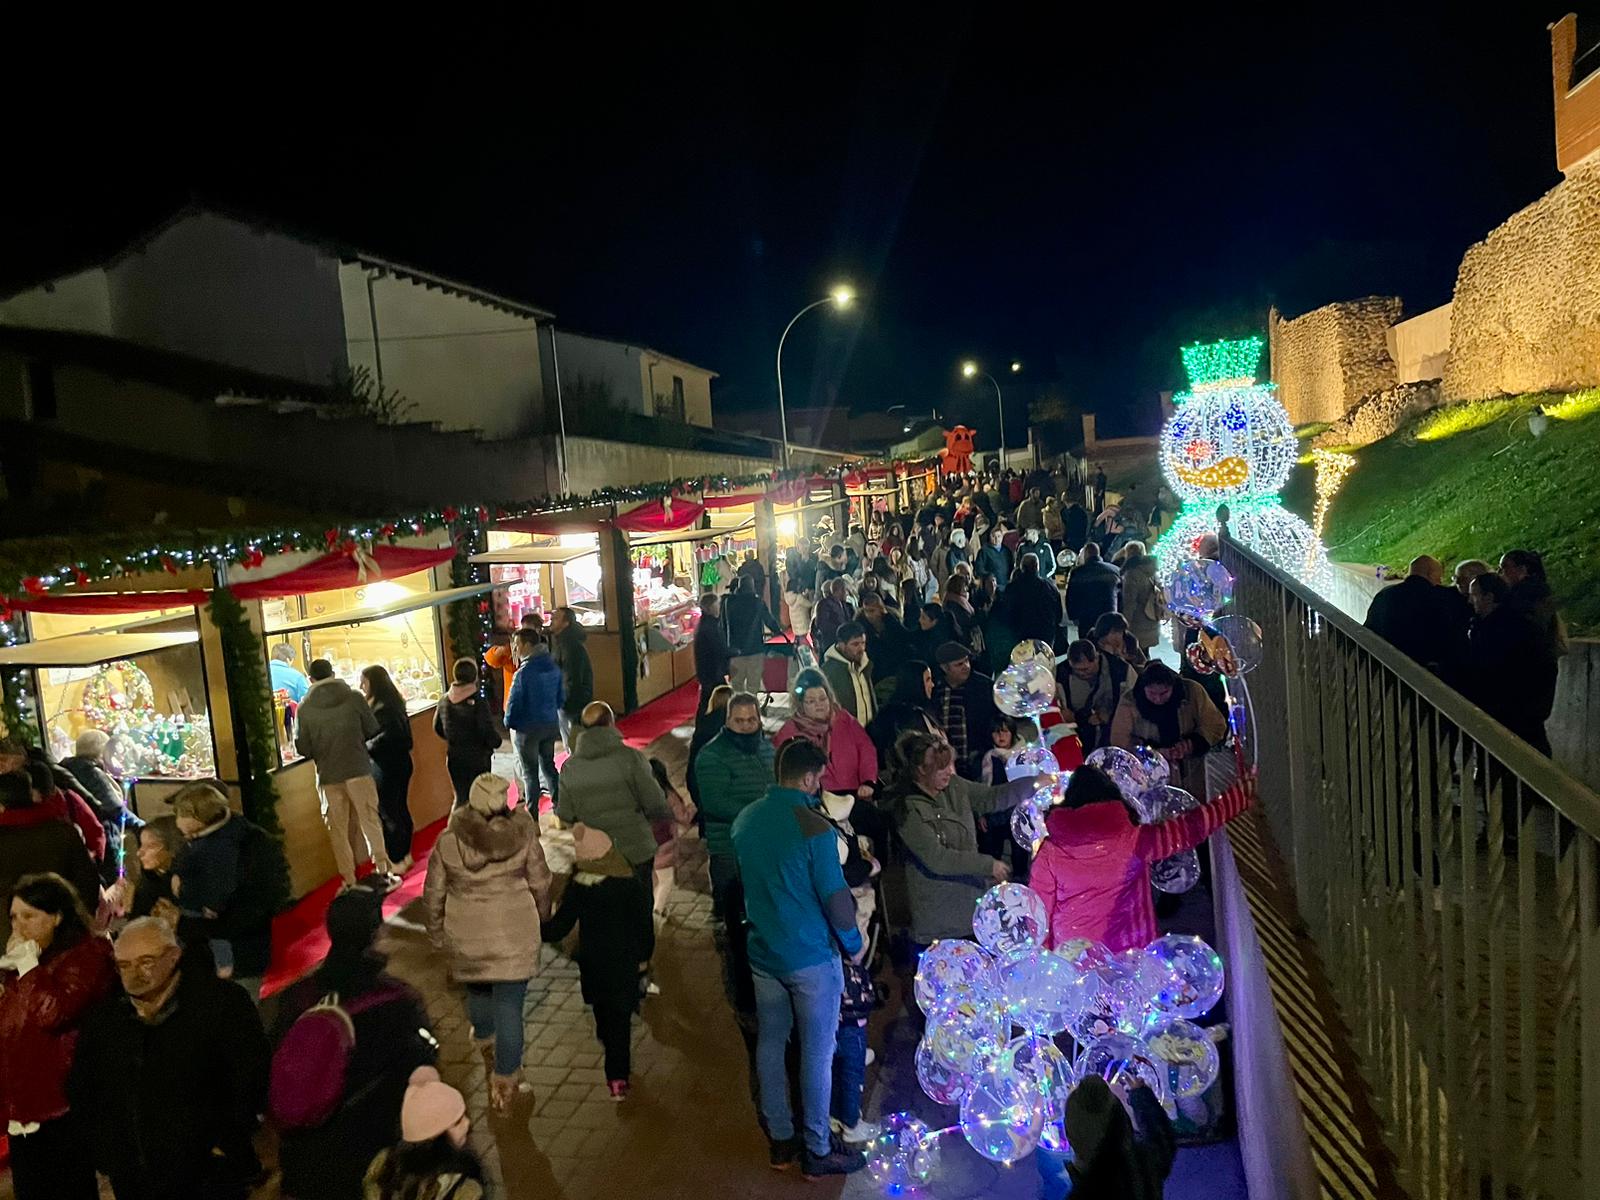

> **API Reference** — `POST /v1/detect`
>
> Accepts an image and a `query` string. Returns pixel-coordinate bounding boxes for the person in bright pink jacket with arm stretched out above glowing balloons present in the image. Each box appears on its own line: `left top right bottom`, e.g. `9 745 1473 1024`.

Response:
1027 766 1256 950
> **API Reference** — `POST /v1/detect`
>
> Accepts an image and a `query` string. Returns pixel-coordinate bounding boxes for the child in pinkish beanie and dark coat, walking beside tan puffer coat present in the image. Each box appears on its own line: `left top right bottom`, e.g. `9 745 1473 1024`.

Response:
541 824 656 1101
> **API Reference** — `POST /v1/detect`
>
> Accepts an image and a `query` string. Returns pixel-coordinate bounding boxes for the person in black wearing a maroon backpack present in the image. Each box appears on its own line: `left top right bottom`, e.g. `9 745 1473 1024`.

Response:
267 888 438 1200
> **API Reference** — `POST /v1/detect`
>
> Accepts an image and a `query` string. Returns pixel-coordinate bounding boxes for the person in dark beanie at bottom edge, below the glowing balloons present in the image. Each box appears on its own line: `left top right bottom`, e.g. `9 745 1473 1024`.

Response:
1035 1075 1178 1200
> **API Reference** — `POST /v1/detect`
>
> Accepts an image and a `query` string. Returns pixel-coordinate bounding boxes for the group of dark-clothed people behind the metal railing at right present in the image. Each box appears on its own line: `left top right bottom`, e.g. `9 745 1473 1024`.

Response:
1366 549 1566 757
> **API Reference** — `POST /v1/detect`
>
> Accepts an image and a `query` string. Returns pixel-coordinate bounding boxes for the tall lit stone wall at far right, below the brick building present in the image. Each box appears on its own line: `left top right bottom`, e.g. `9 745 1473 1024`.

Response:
1443 163 1600 400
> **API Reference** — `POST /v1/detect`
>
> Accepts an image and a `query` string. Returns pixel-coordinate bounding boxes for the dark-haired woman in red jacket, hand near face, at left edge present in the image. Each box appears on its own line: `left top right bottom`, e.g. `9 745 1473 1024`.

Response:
0 872 117 1200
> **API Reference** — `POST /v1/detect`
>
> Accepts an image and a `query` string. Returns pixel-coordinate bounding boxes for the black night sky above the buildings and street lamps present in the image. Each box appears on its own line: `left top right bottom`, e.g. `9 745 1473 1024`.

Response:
0 3 1566 442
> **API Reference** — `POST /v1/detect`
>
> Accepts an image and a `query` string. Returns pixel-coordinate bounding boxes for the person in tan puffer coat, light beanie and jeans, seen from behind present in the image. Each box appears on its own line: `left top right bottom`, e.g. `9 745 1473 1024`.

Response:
422 774 553 1112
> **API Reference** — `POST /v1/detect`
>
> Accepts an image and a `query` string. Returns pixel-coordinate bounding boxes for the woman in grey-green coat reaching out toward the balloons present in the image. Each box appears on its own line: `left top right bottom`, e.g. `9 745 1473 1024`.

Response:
890 733 1038 946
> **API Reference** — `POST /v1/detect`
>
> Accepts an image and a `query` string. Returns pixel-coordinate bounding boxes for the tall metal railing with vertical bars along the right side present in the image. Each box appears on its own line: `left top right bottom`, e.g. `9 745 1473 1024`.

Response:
1222 544 1600 1200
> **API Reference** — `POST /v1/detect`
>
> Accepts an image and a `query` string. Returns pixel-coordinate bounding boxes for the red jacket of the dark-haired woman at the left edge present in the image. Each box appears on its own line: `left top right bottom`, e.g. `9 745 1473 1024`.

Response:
0 936 117 1123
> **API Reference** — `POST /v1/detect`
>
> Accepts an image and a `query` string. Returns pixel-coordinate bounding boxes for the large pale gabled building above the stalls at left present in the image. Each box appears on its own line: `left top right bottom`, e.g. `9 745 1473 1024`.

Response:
0 208 550 438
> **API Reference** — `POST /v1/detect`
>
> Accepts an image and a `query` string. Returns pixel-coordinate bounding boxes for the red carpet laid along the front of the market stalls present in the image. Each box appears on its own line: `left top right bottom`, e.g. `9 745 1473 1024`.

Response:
261 683 699 997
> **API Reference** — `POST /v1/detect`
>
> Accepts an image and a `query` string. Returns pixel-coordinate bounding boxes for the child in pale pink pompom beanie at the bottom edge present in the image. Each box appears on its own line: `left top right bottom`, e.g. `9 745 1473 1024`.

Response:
363 1067 488 1200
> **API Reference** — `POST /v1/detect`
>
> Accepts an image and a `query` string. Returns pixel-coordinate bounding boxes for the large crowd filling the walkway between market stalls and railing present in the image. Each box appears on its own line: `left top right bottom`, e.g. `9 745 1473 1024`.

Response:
0 472 1238 1200
